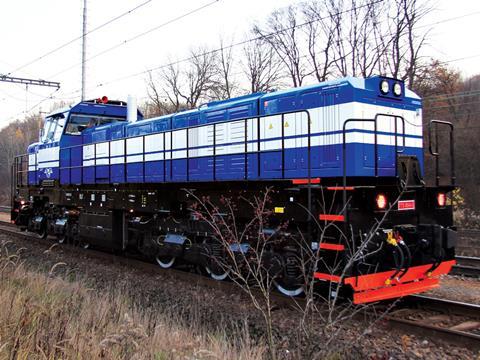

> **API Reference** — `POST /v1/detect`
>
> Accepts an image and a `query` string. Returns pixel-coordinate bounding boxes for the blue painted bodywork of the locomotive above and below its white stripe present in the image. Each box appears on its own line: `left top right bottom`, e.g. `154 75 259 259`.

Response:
29 77 423 185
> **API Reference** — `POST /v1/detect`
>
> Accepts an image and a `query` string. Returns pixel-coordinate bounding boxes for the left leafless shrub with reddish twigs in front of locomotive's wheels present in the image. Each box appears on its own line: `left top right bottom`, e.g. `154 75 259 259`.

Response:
187 188 277 359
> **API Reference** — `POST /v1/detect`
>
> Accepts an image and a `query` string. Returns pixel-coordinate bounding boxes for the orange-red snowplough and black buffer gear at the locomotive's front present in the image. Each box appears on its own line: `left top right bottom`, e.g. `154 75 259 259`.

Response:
314 224 456 304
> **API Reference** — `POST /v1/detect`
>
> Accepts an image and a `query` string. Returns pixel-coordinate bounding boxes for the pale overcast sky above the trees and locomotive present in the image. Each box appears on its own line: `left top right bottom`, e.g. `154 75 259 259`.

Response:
0 0 480 127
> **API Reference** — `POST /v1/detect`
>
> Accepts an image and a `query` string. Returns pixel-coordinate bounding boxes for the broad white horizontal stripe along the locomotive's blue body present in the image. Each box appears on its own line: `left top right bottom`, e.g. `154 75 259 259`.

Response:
53 102 423 169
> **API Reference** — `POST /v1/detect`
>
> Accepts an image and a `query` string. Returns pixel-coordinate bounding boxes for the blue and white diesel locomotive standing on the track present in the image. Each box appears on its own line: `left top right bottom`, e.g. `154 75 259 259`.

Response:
12 77 455 303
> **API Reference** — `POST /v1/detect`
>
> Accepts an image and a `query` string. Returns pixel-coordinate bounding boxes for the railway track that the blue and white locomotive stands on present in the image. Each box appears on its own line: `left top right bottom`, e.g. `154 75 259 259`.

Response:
0 223 480 351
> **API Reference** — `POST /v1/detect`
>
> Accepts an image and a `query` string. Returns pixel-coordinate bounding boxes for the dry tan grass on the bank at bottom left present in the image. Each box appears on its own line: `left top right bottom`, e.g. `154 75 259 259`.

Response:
0 243 265 359
